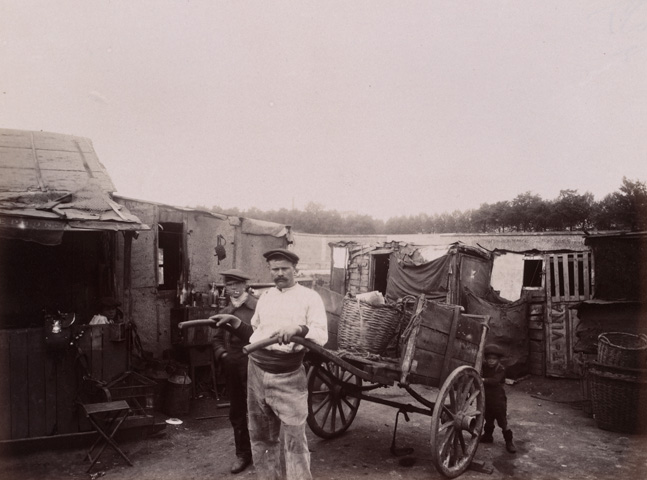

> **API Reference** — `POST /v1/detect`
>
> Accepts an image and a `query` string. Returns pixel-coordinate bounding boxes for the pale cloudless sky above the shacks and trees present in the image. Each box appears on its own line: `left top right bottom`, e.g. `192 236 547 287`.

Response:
0 0 647 220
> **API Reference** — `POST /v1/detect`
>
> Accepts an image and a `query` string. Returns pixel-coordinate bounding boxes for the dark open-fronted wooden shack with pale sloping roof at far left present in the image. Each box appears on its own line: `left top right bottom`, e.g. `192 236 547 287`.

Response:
0 129 148 441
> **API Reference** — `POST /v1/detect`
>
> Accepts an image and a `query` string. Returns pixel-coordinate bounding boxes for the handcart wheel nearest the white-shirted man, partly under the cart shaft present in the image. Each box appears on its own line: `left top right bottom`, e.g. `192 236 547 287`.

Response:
308 362 362 438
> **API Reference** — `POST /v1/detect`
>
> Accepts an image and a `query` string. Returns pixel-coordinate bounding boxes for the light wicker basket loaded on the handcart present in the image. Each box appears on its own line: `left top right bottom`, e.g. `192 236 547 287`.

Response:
337 297 402 355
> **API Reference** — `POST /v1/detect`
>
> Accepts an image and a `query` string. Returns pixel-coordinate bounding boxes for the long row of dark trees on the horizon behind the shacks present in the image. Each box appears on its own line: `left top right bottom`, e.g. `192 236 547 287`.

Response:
199 177 647 235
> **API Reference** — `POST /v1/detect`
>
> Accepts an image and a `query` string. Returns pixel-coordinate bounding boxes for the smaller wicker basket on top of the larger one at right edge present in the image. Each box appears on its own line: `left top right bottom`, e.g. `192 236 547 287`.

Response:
598 332 647 368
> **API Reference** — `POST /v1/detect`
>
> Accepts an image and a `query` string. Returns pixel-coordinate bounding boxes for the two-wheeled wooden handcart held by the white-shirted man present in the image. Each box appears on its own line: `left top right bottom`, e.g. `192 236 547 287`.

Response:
180 297 490 478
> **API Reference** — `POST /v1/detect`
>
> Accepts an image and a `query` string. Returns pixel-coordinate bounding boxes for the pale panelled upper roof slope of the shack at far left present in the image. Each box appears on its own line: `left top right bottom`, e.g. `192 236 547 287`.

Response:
0 129 115 198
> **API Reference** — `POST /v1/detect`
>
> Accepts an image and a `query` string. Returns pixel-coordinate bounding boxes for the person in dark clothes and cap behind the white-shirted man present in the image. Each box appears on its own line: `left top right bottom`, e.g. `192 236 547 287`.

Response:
213 268 257 473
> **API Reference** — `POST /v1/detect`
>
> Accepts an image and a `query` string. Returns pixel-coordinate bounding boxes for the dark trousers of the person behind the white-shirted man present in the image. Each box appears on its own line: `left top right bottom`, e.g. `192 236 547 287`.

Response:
221 352 252 458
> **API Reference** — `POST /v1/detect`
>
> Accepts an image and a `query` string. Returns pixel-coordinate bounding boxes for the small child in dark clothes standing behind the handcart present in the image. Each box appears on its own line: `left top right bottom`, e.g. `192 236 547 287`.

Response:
481 344 517 453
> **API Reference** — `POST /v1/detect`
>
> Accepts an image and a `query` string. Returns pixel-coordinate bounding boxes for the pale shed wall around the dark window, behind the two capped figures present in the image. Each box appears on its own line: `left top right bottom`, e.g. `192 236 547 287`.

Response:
117 198 287 357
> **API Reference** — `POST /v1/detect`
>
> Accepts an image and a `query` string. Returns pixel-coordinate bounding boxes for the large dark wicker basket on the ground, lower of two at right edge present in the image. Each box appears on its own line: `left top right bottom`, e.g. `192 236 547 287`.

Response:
588 363 647 433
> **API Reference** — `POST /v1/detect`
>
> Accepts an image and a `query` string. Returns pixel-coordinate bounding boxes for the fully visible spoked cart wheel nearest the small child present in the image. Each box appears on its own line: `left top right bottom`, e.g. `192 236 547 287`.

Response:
431 366 485 478
